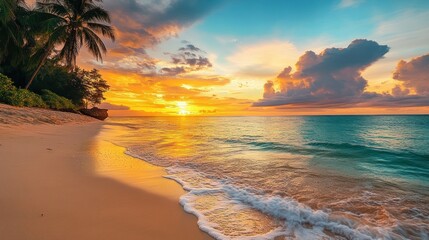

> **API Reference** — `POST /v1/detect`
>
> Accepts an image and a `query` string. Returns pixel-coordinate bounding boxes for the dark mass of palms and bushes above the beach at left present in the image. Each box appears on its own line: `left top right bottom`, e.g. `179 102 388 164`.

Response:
0 0 115 109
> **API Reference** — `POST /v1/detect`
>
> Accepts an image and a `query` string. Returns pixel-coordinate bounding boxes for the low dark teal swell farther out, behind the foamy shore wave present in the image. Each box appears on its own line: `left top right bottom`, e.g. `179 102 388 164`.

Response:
216 138 429 179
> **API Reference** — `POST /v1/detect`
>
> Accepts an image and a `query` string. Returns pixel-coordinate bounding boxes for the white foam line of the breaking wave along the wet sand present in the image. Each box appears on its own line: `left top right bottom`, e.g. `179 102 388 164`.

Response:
125 150 389 240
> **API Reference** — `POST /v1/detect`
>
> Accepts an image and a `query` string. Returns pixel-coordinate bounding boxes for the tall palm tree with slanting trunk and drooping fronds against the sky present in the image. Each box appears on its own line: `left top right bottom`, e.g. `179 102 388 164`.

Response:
25 0 115 89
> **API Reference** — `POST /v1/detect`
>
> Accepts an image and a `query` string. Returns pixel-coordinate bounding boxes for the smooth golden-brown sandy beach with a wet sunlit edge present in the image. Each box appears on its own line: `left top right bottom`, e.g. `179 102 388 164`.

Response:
0 105 210 240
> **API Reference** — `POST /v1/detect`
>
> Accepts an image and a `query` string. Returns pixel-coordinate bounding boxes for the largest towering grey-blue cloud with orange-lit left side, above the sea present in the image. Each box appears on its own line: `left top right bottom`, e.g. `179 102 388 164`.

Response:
255 39 389 106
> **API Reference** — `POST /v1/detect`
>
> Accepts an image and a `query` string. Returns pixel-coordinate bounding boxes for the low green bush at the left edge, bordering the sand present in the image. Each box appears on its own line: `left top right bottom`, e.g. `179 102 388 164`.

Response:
0 74 46 108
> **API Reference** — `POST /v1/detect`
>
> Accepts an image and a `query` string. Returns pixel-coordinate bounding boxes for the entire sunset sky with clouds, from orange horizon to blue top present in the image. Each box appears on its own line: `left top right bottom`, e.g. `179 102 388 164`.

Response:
74 0 429 116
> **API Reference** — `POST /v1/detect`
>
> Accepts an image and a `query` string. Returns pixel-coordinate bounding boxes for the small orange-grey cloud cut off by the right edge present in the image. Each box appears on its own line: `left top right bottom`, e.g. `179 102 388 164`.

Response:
393 54 429 95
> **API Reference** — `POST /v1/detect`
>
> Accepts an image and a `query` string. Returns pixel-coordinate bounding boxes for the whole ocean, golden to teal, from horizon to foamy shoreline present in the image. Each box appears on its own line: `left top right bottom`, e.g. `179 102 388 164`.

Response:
105 115 429 239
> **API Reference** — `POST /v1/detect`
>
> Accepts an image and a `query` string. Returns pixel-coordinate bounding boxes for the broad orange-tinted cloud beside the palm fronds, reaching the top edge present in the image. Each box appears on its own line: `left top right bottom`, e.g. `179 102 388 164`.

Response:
79 0 223 75
